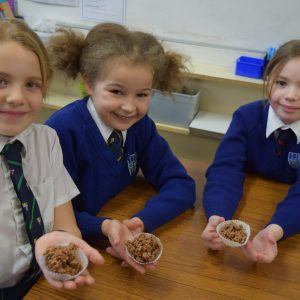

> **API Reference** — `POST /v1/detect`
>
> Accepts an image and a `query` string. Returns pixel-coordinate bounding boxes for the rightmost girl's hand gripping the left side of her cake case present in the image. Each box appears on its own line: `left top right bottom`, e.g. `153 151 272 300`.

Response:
201 216 225 250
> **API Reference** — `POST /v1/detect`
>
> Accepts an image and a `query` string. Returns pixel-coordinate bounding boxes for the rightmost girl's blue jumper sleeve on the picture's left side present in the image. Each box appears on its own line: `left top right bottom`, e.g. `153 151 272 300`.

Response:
203 112 248 219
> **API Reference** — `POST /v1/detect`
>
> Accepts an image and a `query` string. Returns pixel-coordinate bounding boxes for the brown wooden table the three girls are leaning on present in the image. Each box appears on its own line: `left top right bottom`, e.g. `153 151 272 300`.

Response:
26 161 300 300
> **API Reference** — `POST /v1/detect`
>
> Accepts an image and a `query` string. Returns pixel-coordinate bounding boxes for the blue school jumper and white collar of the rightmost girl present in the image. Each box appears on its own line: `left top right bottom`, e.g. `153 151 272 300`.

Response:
203 100 300 238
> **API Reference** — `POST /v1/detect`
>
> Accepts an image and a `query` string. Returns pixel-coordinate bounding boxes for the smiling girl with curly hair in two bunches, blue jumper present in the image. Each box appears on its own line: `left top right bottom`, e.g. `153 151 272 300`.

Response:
47 24 195 273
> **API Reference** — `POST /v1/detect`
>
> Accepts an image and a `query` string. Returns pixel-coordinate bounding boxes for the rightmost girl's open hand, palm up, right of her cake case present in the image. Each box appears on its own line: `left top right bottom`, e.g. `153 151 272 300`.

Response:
243 224 283 263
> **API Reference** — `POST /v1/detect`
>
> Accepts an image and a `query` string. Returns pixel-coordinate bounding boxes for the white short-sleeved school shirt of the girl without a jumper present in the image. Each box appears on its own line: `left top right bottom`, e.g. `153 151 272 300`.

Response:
0 124 79 299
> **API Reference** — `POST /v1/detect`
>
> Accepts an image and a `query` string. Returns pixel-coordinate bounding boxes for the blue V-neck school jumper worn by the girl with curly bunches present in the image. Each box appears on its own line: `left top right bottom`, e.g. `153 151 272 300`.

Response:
46 97 195 238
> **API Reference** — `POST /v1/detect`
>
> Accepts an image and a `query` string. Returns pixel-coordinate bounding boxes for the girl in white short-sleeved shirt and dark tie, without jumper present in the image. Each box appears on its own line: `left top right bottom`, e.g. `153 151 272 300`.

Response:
0 19 104 300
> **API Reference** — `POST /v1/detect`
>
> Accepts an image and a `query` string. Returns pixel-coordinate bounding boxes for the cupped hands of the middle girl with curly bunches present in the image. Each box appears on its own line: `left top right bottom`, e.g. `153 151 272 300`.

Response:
102 218 155 274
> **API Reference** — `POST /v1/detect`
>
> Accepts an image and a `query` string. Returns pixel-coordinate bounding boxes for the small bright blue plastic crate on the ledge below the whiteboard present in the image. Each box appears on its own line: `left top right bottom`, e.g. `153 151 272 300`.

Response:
235 56 266 79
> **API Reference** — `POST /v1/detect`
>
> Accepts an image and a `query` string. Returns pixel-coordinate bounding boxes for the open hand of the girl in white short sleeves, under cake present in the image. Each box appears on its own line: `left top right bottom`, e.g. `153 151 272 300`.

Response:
35 231 104 290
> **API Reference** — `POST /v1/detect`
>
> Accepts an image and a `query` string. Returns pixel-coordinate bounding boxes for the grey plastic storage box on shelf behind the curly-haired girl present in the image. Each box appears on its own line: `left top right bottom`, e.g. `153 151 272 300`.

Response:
149 89 200 128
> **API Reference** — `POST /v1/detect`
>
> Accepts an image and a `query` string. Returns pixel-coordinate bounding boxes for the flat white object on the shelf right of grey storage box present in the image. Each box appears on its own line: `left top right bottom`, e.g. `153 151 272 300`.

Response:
189 111 231 138
